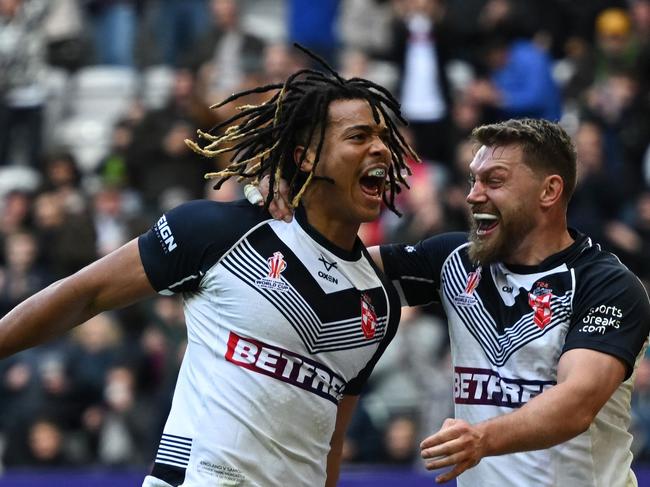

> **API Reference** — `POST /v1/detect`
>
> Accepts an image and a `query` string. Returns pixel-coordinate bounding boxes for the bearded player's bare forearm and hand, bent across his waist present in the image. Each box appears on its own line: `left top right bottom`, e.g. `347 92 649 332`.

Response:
420 349 626 483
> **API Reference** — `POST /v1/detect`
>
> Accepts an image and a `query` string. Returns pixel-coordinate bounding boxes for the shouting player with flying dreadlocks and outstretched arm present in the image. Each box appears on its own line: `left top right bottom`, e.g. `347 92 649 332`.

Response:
0 46 416 487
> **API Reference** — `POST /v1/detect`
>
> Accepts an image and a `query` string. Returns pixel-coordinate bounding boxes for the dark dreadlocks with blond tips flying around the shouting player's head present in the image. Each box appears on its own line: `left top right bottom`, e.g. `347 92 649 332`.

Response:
185 44 420 215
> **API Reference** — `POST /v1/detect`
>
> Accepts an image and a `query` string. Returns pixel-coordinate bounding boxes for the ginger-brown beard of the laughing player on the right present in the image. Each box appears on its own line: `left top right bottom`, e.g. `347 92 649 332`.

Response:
468 203 535 265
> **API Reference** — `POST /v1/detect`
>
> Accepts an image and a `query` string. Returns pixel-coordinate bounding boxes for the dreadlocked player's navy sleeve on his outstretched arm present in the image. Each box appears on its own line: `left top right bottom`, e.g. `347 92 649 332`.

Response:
138 200 270 293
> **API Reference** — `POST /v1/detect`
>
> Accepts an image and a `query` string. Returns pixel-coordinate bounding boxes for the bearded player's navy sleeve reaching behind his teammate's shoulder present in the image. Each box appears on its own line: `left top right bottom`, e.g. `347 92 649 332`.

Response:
380 233 467 306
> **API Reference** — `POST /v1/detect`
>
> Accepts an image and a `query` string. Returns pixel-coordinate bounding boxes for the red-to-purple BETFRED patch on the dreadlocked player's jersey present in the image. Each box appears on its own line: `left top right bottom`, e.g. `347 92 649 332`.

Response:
226 332 345 404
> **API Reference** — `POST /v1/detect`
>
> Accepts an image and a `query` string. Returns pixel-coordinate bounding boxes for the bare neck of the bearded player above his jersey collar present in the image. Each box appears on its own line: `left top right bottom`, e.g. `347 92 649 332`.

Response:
506 217 574 265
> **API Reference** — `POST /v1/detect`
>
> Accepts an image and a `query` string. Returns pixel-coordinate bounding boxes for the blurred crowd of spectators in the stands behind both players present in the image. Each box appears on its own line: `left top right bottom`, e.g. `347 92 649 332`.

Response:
0 0 650 468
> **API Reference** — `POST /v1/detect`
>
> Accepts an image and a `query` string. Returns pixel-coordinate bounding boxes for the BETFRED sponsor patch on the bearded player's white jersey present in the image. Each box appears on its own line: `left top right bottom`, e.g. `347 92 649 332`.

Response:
454 367 555 408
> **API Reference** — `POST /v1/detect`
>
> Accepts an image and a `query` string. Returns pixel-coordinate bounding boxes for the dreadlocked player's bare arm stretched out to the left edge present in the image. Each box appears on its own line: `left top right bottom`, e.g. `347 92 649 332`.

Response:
0 239 155 358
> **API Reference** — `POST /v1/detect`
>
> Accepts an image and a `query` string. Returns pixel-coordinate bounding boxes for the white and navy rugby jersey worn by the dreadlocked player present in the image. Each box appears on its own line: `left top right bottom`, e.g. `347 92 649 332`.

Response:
139 200 400 487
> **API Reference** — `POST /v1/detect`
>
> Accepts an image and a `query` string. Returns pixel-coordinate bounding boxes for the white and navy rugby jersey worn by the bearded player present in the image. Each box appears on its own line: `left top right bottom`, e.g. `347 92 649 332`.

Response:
381 230 650 487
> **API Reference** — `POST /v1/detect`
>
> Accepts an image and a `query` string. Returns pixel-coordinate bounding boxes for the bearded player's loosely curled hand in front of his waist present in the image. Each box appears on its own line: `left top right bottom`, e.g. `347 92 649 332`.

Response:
420 418 483 483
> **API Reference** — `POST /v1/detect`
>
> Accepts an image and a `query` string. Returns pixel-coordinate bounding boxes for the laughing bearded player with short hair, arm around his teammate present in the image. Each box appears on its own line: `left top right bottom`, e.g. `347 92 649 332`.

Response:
252 119 650 487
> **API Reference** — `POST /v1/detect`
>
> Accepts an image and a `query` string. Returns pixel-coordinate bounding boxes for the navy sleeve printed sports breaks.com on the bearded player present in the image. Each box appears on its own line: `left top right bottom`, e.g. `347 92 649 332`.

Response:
563 263 650 379
